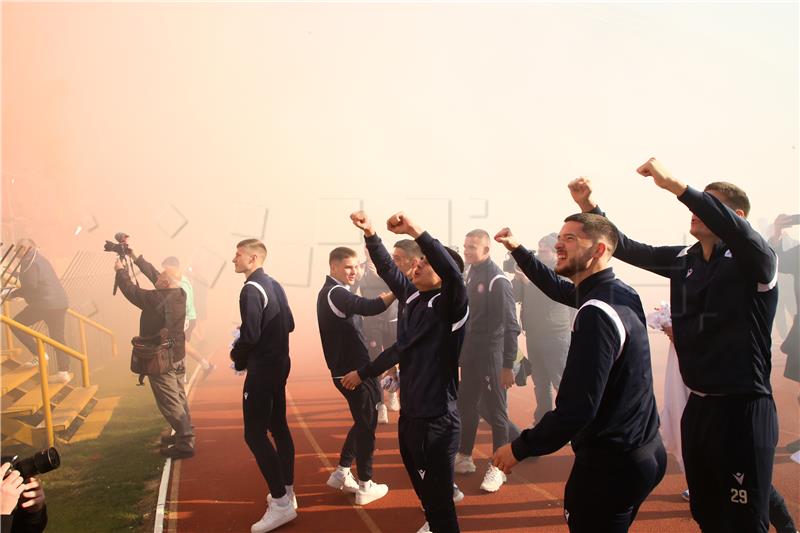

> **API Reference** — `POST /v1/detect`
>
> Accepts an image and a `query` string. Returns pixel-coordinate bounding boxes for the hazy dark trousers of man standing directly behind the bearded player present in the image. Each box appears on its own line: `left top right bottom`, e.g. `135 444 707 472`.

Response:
525 335 569 424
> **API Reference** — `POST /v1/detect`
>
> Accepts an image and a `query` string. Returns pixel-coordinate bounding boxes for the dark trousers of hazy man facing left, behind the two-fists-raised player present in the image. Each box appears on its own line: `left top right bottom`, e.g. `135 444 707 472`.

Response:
458 364 510 455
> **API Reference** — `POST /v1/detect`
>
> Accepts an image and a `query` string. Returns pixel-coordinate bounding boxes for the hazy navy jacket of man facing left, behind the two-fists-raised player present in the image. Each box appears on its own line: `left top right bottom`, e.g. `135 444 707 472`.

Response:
460 258 520 373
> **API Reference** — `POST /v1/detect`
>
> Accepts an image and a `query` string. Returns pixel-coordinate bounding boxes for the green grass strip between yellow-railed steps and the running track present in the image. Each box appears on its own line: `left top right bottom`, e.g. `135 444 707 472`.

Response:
20 355 167 533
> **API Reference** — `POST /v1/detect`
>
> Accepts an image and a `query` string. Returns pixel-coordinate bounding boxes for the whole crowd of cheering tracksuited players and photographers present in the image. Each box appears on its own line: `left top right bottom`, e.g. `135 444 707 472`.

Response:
2 159 800 533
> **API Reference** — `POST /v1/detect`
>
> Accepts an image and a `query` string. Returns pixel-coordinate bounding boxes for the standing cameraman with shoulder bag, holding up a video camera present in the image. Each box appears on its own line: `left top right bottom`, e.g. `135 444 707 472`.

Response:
114 246 194 459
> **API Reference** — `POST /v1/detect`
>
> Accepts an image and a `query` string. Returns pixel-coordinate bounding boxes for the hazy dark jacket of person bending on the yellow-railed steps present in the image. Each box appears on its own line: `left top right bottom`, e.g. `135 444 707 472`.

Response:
10 249 69 309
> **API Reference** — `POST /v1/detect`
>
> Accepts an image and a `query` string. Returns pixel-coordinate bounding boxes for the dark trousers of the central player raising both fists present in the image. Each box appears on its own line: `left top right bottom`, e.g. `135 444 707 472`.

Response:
397 411 461 533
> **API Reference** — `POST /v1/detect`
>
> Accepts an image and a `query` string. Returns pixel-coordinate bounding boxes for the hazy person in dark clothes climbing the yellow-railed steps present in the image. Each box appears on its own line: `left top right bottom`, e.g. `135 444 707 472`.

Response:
9 239 72 383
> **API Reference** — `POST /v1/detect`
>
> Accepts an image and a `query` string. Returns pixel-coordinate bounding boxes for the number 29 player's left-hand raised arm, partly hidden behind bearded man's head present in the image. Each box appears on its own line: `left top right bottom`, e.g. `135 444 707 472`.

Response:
567 176 684 278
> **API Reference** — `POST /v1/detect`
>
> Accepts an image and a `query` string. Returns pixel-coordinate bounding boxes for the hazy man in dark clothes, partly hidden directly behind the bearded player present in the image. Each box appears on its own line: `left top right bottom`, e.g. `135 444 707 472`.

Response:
511 233 574 425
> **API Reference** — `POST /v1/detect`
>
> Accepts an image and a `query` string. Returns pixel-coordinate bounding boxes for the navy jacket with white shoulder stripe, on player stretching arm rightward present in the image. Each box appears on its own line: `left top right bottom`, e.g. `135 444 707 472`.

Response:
317 276 386 377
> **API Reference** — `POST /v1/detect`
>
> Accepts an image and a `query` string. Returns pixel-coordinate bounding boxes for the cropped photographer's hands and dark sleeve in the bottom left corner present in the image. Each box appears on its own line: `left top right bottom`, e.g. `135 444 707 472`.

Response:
0 463 47 533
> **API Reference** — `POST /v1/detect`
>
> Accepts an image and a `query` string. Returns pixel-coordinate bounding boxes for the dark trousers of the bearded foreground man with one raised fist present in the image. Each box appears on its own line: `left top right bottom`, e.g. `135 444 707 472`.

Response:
564 437 667 533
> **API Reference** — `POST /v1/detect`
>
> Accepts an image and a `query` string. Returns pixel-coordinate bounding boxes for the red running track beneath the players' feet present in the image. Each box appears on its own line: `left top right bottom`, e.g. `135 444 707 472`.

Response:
165 338 800 533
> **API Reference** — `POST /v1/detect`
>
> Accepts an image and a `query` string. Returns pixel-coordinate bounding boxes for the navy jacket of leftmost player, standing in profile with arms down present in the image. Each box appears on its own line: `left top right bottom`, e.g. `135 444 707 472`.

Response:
231 268 294 379
